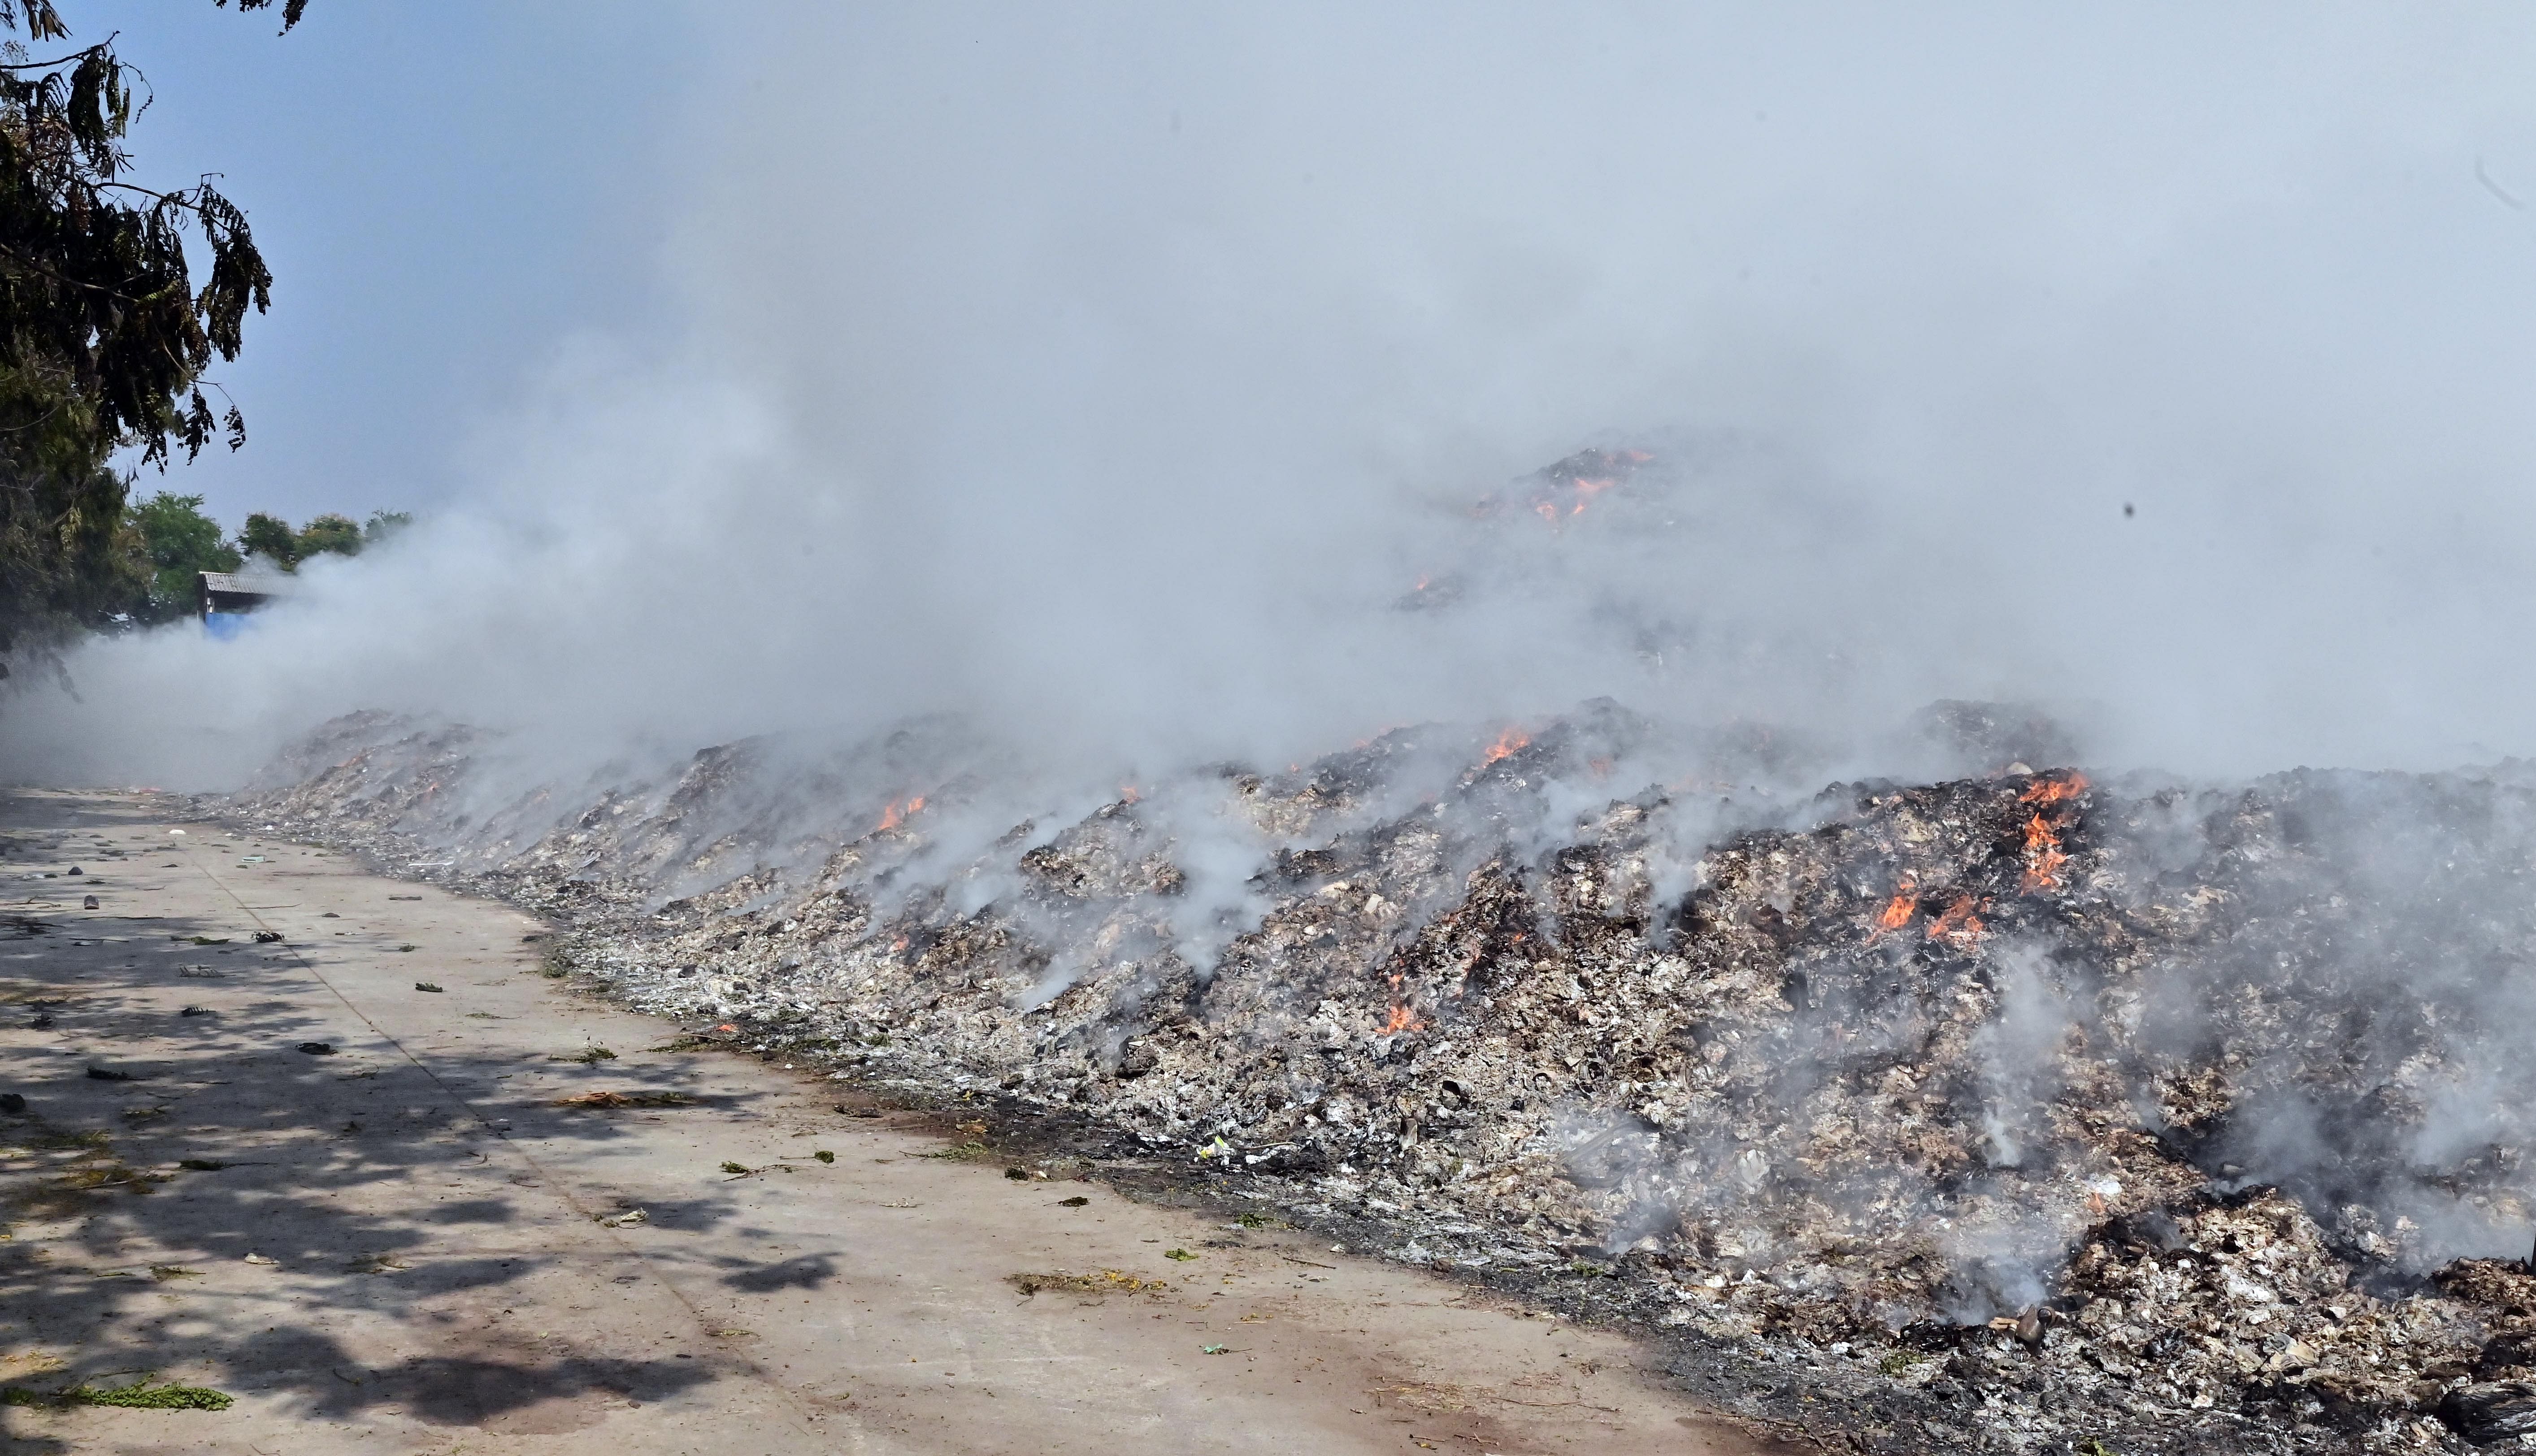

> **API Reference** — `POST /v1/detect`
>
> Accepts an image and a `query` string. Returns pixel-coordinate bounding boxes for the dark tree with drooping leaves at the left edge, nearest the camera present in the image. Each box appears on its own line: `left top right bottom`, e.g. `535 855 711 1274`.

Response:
0 0 307 675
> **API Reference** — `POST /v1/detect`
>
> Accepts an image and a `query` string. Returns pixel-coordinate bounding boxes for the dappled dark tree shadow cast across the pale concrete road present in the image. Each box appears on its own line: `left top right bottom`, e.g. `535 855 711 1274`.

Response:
0 819 786 1451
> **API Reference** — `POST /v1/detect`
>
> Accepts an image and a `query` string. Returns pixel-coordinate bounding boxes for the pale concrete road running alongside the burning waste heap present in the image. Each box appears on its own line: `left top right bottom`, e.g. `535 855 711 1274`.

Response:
0 791 1763 1456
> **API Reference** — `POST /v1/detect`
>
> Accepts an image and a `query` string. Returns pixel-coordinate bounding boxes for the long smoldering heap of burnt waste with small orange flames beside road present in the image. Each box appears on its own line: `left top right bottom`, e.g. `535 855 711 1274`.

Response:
223 705 2536 1451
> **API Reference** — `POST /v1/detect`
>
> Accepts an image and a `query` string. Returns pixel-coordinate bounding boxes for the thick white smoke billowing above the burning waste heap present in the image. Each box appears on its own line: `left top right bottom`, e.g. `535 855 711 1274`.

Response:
0 5 2536 786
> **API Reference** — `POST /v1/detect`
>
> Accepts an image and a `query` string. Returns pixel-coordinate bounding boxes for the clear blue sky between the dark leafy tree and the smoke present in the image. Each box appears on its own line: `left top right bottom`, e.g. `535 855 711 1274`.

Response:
63 0 700 528
